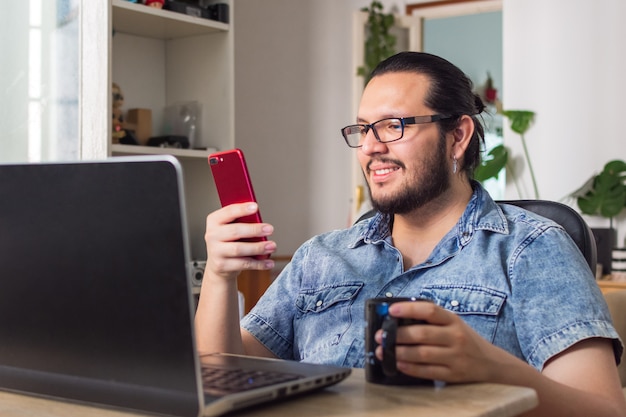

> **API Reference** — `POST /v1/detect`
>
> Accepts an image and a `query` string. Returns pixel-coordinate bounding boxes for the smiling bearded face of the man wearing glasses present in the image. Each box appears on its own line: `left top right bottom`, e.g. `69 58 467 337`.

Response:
357 72 450 214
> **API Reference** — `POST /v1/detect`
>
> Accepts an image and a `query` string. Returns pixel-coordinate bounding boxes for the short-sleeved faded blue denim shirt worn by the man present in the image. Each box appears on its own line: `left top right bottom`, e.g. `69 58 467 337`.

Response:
241 183 622 370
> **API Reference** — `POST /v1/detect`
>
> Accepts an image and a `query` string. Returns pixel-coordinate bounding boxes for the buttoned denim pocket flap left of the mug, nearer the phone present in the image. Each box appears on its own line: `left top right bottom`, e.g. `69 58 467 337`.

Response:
296 282 363 314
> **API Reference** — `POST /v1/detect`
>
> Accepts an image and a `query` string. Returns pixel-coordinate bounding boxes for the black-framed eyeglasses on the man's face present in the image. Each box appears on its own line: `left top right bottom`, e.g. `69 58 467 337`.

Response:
341 114 453 148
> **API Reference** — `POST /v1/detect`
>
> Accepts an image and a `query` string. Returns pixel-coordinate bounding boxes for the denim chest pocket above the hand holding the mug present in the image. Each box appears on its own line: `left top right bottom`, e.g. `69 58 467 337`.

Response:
421 285 506 341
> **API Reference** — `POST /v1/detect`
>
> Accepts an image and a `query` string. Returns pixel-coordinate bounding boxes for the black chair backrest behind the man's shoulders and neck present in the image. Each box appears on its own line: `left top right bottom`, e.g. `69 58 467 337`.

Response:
357 200 597 276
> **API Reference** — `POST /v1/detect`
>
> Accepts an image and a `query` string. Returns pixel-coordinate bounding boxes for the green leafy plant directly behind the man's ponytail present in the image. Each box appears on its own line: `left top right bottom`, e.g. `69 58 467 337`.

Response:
474 110 539 199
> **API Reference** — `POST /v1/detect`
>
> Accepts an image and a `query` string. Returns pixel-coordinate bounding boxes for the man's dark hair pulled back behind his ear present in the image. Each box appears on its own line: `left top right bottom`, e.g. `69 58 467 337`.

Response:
371 52 485 178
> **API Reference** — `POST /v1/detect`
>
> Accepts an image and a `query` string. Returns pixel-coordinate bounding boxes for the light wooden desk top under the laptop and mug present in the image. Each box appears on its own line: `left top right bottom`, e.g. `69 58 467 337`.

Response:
0 369 538 417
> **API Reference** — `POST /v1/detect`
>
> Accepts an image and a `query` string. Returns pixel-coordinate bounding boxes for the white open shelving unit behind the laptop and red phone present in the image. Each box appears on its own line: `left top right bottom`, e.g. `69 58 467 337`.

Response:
107 0 235 259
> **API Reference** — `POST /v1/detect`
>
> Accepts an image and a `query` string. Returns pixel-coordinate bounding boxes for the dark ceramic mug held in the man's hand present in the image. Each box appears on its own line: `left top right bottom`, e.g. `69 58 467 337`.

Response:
365 297 433 385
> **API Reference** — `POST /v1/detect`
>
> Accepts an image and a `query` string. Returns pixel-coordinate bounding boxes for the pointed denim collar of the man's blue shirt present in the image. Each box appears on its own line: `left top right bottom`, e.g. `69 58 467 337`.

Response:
349 180 509 255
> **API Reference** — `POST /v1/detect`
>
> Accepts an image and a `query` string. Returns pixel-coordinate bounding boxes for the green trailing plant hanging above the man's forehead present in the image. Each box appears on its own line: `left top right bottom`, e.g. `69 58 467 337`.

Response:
357 0 396 84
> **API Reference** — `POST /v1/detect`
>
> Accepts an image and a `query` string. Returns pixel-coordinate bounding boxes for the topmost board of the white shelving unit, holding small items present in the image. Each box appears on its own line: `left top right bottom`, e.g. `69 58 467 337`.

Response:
111 0 229 39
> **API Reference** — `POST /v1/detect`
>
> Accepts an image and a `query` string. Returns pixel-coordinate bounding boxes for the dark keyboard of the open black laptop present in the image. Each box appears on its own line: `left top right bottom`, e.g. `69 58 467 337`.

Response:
202 367 300 395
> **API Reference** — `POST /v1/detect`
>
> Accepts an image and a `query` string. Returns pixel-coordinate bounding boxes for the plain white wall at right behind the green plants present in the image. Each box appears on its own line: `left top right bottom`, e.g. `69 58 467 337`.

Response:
503 0 626 243
